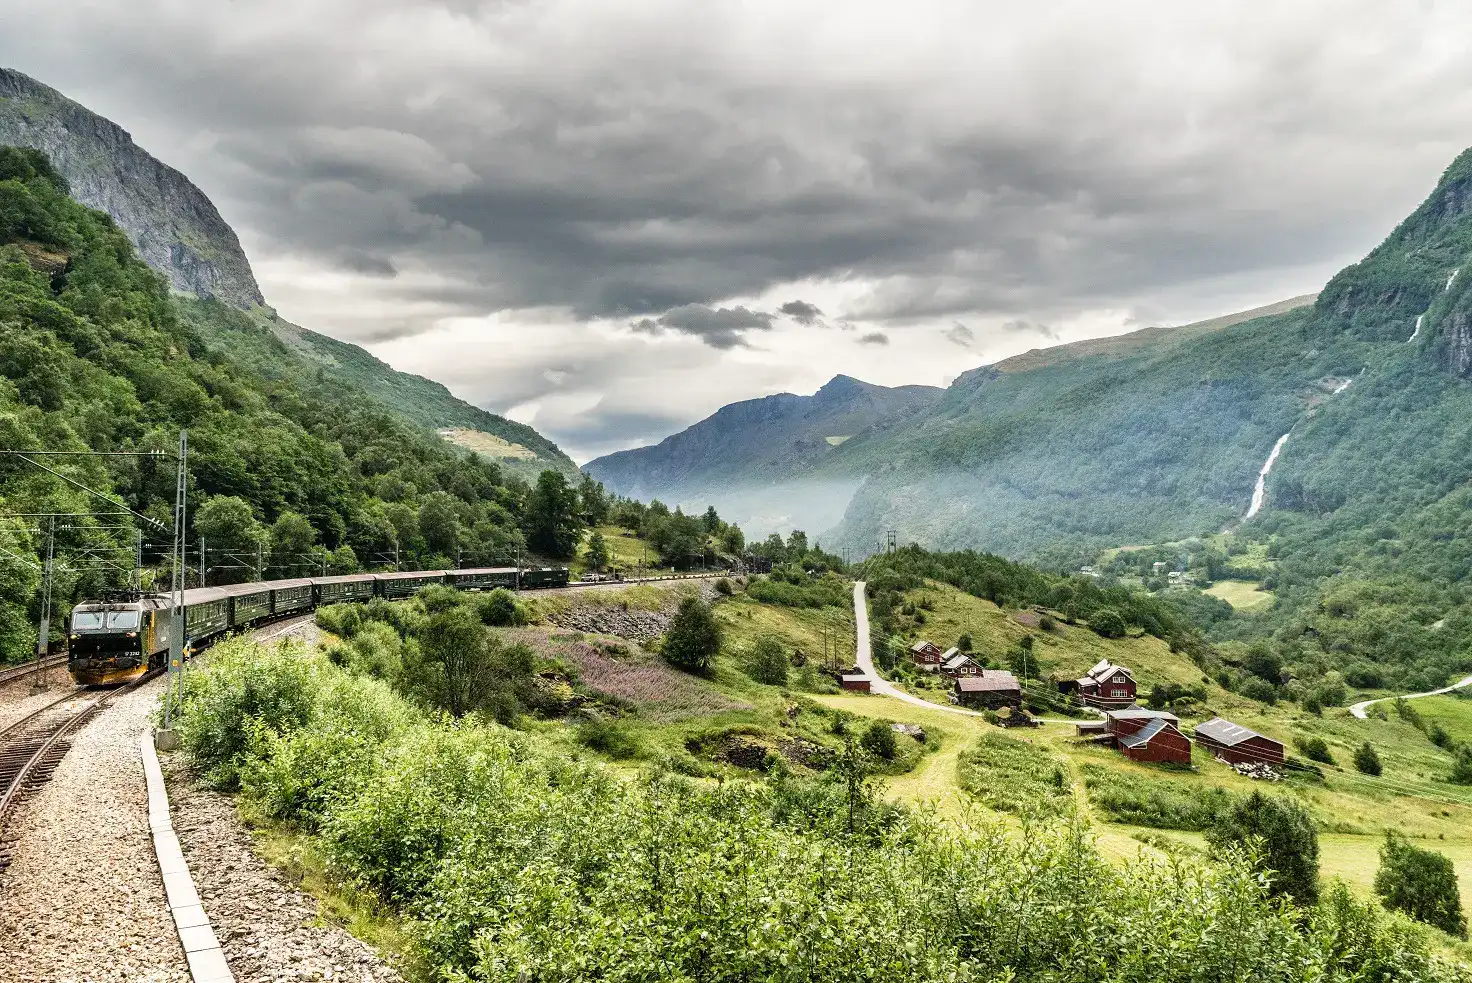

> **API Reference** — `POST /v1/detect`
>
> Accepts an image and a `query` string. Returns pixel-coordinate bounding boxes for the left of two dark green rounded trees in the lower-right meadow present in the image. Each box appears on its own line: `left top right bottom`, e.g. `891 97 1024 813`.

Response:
1206 792 1319 905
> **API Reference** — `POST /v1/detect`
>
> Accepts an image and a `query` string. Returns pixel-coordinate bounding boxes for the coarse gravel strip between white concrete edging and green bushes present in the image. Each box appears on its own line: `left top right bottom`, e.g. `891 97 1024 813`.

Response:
163 755 400 983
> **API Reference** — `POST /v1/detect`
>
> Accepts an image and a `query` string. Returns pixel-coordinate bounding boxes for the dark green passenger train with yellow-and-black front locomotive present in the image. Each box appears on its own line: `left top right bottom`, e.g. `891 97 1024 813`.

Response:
66 567 570 686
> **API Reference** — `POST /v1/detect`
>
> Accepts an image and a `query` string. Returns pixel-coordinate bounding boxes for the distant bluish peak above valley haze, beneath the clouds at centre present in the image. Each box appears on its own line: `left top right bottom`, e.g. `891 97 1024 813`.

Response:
583 375 942 533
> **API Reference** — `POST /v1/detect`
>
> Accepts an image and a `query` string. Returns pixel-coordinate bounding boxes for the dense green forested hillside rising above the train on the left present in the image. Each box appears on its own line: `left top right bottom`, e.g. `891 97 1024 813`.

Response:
0 147 591 658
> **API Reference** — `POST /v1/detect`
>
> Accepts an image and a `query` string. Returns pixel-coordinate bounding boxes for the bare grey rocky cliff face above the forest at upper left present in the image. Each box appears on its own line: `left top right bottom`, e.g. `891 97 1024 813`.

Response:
0 68 263 309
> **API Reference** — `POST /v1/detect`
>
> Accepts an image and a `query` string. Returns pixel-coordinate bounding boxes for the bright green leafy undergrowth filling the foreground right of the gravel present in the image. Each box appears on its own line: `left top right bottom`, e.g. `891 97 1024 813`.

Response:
180 643 1465 983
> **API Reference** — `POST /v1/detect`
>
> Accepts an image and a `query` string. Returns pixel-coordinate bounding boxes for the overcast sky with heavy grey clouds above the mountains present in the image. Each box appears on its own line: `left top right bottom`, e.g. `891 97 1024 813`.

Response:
0 0 1472 461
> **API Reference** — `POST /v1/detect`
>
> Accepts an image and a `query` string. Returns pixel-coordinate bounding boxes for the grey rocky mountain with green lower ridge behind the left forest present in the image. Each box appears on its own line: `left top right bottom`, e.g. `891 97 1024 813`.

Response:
0 68 577 475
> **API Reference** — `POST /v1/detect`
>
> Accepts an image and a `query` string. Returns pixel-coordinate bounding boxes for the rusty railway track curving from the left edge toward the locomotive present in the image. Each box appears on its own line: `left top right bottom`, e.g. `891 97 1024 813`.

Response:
0 671 158 870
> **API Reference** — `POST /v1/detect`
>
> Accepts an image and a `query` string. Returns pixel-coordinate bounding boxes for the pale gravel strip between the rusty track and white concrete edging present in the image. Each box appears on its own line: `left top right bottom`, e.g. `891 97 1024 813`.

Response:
0 680 188 983
